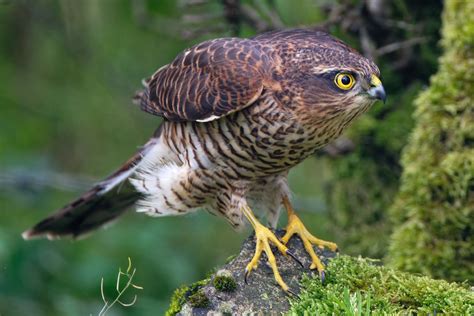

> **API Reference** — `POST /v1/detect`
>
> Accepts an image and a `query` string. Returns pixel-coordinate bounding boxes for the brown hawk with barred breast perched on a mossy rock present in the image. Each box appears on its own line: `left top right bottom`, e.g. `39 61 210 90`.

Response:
23 29 386 293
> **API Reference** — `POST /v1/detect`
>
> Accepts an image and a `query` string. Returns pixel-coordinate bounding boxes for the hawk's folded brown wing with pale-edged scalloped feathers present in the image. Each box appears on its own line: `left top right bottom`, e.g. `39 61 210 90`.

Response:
136 38 271 121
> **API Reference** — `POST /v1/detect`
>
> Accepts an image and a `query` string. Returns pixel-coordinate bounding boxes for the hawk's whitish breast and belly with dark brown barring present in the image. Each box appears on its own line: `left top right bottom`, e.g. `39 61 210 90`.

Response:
131 95 316 228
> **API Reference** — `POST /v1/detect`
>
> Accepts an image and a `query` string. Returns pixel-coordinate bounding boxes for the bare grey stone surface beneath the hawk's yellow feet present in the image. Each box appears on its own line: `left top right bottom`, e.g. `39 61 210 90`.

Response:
178 231 336 315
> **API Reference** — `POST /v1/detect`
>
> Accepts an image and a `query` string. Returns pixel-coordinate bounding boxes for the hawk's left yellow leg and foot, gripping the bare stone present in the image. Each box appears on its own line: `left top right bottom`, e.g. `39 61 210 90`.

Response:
242 206 294 294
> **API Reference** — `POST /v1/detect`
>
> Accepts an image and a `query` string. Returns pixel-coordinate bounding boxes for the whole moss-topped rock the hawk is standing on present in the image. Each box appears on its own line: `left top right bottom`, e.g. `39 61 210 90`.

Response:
167 231 474 315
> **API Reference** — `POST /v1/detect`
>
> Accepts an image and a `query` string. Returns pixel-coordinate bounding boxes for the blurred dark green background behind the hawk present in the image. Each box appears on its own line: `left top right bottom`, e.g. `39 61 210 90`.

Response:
0 0 442 315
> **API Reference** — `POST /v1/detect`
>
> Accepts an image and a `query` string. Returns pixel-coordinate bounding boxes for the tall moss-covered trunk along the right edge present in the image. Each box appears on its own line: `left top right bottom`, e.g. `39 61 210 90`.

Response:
389 1 474 282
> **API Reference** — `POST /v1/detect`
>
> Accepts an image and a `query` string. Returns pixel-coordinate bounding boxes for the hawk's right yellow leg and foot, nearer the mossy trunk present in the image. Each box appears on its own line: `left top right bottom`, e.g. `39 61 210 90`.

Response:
281 197 337 280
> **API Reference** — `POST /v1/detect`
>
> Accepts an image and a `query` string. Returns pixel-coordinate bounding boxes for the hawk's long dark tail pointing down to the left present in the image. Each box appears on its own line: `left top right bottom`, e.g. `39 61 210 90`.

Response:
22 134 160 239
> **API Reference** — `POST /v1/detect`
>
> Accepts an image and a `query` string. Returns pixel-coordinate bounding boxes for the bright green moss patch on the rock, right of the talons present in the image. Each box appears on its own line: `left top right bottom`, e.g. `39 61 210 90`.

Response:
289 256 474 315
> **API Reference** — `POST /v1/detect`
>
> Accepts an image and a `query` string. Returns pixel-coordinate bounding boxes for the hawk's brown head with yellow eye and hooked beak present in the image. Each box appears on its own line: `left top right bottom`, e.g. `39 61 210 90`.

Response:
276 31 386 120
